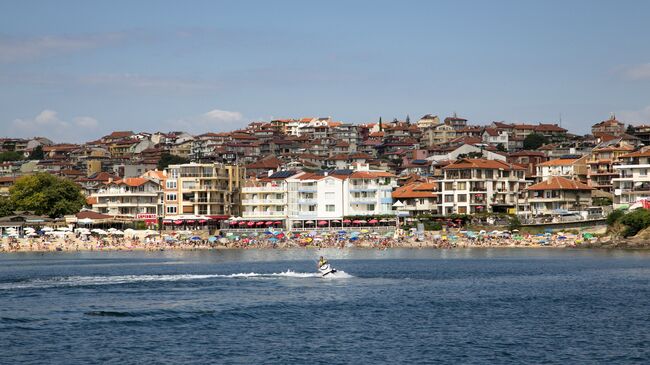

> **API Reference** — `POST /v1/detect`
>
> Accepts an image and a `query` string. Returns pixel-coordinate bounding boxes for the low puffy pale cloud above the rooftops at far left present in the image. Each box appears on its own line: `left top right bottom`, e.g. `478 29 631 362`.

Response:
11 109 99 142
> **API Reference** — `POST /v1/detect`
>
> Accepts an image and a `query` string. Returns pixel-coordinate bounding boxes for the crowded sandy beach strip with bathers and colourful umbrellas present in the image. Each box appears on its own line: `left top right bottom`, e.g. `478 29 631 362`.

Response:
0 228 597 252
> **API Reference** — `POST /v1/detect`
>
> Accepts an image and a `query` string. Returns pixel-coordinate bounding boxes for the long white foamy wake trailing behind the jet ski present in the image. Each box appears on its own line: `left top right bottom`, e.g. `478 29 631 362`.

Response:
0 270 353 290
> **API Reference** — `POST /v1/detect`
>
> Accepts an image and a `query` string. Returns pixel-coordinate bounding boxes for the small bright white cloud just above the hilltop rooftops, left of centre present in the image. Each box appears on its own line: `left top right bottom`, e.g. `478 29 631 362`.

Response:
165 109 245 133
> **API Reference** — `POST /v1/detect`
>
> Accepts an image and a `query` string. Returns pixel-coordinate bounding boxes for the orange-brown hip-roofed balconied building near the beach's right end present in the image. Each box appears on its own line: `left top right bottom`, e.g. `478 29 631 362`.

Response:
526 176 592 216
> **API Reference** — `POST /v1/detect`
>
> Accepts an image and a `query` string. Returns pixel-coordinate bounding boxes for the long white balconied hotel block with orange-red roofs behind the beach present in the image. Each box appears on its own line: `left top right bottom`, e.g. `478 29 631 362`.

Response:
234 165 397 228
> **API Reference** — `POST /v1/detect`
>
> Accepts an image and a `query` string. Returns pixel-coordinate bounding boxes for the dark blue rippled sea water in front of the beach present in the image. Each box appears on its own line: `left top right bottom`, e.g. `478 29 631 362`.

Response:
0 249 650 364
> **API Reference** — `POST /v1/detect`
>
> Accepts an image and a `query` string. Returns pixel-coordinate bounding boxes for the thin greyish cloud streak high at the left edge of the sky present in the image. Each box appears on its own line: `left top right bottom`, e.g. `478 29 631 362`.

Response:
0 33 125 63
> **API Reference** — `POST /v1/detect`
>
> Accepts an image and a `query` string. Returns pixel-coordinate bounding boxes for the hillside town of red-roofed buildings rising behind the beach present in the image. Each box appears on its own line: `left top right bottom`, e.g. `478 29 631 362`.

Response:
0 114 650 231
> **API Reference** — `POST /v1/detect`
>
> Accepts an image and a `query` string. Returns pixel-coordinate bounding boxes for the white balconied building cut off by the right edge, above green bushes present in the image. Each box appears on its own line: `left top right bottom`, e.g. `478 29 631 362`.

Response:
612 150 650 209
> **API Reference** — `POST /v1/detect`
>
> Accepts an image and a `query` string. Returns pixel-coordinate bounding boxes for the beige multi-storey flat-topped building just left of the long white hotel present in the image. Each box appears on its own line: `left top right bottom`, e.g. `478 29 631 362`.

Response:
165 163 246 220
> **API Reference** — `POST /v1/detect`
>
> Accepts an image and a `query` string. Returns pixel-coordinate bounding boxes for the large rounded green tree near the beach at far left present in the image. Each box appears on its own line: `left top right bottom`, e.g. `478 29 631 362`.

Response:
9 173 86 218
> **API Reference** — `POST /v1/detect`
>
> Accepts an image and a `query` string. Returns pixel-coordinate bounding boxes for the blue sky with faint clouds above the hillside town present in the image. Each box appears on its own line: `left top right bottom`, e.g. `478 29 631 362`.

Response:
0 0 650 142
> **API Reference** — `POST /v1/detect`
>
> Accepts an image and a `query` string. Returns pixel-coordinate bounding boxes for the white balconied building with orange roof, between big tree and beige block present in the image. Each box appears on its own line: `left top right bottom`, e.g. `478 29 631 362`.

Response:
88 177 163 219
